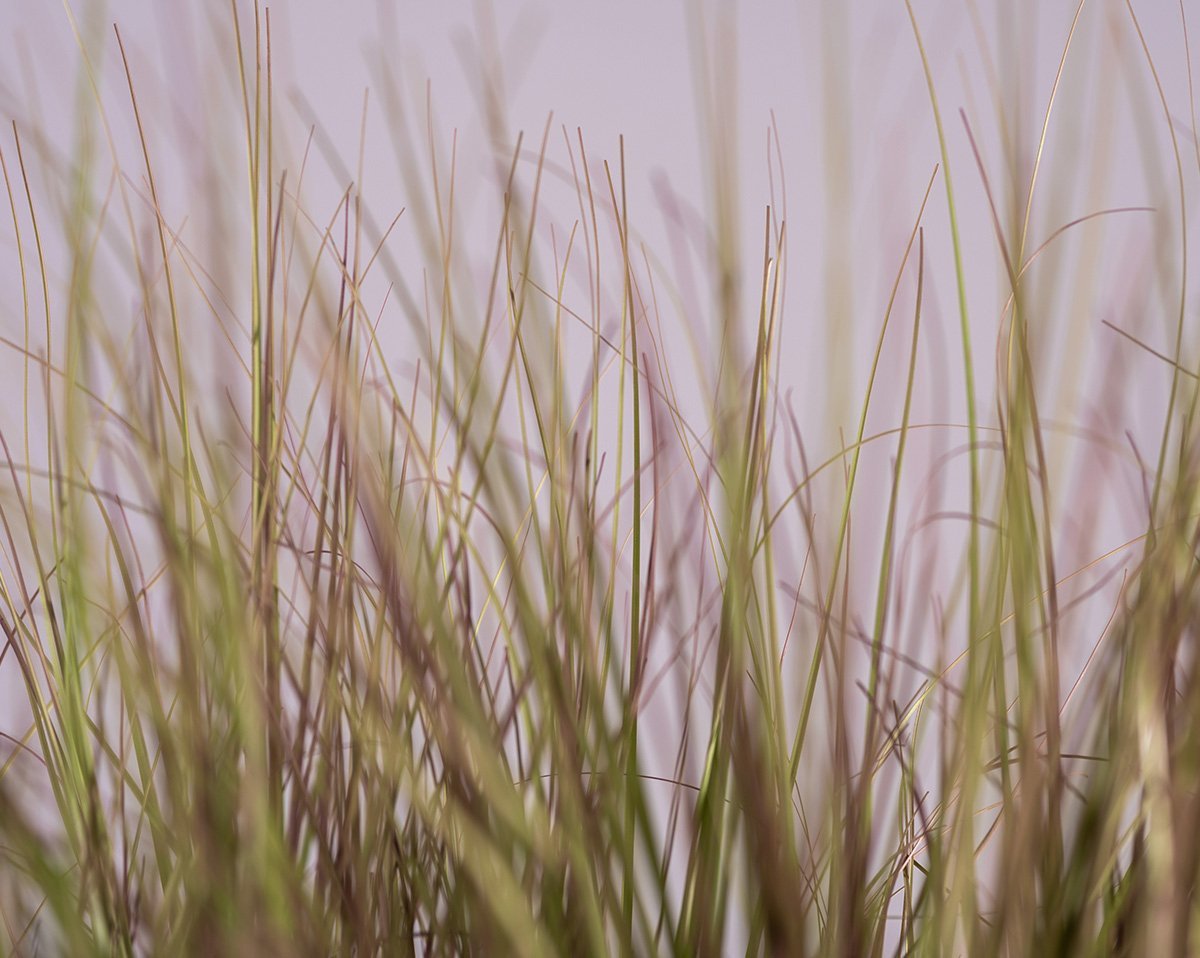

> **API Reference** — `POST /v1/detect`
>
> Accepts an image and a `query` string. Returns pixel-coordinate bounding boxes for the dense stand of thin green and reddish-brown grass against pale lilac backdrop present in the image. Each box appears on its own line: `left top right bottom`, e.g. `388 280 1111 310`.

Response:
0 2 1200 956
